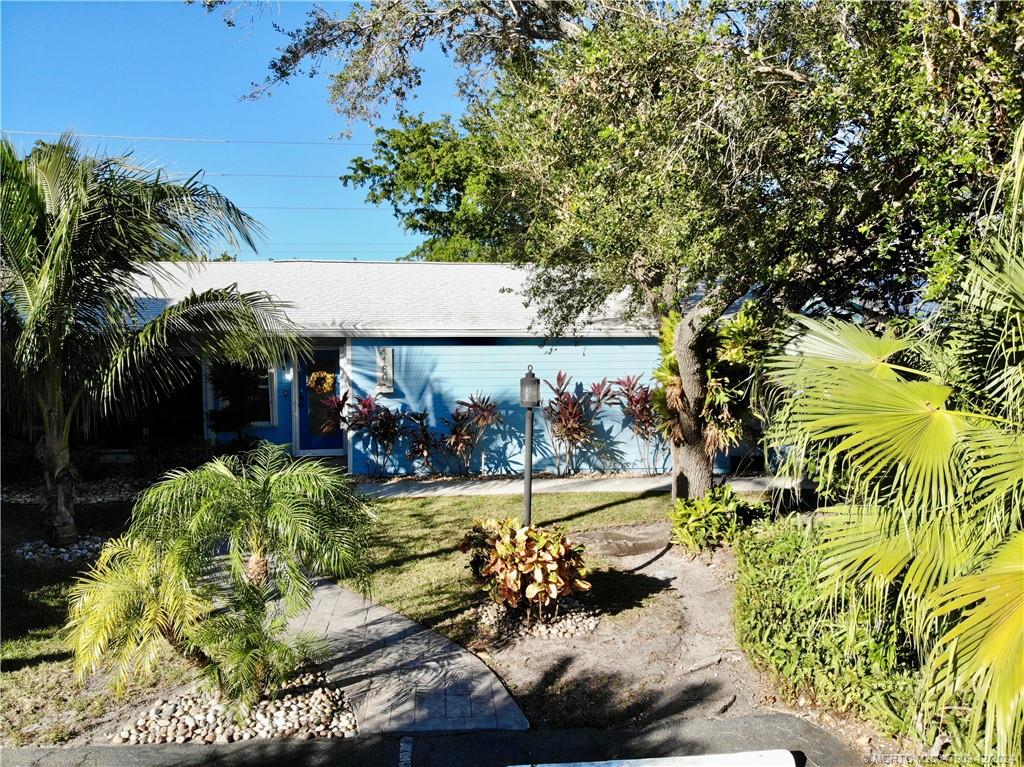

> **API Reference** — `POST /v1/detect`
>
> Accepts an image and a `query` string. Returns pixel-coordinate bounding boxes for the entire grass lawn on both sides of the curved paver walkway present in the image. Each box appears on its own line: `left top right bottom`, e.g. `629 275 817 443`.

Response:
0 494 669 745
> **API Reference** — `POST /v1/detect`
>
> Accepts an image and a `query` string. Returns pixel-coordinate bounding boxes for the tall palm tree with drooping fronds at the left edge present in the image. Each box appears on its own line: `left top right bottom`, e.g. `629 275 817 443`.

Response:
0 135 304 544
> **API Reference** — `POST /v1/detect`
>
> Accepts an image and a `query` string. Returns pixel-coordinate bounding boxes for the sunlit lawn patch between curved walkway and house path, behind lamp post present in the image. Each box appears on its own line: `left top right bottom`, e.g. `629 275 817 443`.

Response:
358 493 670 644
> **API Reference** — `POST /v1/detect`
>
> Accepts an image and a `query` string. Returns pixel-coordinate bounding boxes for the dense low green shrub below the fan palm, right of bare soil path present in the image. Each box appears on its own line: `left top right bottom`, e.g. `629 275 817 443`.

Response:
733 519 921 734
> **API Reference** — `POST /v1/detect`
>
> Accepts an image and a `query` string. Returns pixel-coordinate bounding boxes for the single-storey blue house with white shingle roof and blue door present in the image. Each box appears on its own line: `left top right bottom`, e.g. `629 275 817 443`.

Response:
145 261 666 474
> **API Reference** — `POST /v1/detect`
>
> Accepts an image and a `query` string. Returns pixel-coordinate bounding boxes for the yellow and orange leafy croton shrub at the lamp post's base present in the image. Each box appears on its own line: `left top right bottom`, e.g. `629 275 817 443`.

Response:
460 517 590 615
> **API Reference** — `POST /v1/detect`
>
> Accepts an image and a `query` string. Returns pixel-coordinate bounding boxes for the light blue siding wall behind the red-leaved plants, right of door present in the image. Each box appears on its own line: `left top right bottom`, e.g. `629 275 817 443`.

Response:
351 338 668 474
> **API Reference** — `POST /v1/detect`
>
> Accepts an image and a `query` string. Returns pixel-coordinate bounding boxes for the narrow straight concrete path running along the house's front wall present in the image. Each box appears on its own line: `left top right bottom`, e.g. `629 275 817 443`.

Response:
358 475 796 499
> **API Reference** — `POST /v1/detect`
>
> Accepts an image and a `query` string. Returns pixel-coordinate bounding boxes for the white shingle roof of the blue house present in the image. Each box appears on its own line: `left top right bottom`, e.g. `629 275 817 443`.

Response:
140 261 650 337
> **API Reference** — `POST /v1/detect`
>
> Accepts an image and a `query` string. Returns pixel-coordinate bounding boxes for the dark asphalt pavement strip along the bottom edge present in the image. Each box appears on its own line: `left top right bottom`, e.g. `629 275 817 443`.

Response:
0 714 862 767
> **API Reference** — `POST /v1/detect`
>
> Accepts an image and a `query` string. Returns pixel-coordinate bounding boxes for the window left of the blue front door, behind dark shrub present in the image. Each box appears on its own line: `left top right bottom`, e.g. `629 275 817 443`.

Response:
208 363 276 437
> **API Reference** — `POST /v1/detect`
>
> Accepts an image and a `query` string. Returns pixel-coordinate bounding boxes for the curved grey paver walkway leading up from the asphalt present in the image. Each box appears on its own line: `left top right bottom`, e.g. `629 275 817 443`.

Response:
292 581 529 733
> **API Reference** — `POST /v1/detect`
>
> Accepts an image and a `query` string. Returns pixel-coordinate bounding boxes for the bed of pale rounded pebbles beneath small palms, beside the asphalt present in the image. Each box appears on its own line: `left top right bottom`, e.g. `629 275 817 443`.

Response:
108 673 356 744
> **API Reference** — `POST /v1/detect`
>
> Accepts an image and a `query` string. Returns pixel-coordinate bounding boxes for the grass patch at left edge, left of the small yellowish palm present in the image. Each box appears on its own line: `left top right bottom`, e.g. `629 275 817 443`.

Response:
0 506 187 745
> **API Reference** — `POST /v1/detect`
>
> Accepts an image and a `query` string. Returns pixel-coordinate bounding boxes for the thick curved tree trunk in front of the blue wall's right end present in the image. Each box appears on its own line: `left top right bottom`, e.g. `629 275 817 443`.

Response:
672 303 714 501
